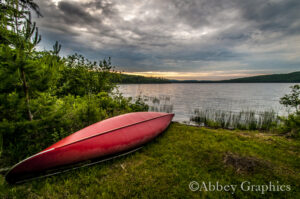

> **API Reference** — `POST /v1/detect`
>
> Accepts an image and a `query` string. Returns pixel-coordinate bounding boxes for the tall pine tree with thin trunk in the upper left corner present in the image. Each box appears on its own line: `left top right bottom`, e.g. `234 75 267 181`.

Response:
0 0 41 121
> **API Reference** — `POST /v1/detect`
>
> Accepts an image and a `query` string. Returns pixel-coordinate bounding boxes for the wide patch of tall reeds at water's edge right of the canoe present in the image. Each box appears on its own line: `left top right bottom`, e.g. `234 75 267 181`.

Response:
190 109 279 130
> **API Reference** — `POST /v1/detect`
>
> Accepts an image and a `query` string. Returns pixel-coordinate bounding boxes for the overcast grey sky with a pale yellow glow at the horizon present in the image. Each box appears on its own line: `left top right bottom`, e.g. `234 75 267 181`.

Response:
34 0 300 80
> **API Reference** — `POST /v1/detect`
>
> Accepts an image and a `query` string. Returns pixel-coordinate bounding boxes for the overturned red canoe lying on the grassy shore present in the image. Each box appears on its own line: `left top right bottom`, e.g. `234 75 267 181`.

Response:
6 112 174 183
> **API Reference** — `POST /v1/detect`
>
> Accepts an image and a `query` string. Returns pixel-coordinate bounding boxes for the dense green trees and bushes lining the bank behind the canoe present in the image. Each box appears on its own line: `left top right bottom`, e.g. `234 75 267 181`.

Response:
0 0 148 167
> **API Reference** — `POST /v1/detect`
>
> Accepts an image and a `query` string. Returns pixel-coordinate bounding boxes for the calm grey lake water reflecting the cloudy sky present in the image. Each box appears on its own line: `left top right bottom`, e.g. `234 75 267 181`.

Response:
119 83 294 122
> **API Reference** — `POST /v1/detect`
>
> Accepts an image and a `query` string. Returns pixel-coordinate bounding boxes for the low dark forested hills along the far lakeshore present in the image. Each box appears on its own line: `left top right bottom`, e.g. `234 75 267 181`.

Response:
117 71 300 84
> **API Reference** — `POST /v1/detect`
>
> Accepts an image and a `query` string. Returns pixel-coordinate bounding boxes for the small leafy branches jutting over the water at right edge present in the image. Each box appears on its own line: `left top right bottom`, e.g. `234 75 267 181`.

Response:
280 85 300 113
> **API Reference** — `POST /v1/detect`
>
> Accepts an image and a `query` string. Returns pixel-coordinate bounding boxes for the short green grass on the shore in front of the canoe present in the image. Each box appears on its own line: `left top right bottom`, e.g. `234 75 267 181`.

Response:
0 123 300 199
